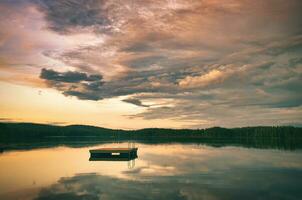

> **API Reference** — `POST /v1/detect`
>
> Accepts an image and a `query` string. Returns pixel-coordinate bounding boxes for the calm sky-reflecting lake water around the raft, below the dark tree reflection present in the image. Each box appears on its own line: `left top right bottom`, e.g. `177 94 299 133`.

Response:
0 143 302 200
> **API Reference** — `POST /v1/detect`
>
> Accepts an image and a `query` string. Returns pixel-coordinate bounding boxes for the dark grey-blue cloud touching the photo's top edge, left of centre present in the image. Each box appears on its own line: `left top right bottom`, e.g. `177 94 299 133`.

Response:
36 0 110 34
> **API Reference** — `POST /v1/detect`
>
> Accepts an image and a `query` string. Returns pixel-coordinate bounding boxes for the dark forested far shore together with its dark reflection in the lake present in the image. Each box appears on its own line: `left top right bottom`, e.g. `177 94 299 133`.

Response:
0 123 302 152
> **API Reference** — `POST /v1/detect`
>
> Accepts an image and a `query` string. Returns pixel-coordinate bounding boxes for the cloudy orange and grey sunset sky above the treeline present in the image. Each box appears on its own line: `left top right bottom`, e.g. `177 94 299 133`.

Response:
0 0 302 129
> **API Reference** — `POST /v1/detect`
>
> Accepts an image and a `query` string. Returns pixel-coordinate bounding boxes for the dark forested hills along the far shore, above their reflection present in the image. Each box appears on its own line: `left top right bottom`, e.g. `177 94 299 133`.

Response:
0 123 302 141
